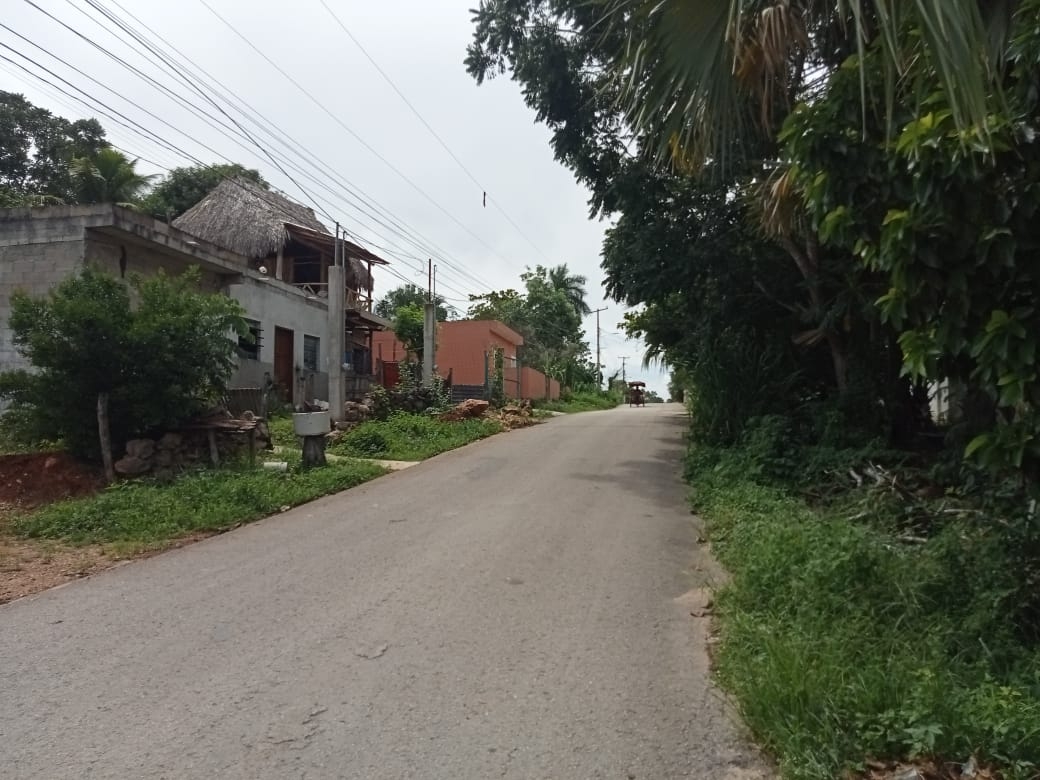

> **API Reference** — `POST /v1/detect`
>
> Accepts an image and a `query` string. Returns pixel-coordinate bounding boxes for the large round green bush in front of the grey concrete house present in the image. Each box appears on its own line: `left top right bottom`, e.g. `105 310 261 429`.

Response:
0 268 245 457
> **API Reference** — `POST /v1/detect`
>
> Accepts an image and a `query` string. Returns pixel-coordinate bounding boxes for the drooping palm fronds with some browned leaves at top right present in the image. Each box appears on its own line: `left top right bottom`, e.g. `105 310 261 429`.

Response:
602 0 1020 164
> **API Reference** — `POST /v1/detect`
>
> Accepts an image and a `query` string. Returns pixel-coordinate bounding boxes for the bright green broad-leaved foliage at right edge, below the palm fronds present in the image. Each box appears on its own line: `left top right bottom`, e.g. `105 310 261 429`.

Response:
781 0 1040 479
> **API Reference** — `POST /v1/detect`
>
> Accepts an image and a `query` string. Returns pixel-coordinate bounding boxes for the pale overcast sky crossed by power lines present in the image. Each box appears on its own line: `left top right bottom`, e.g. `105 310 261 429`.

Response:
0 0 667 394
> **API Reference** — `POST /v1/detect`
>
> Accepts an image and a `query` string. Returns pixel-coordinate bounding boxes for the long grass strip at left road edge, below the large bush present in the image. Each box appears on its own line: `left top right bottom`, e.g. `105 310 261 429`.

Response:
12 461 386 544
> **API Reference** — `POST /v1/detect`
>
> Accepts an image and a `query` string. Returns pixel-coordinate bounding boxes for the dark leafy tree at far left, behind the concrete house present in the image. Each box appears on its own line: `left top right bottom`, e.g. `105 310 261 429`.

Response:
0 90 107 205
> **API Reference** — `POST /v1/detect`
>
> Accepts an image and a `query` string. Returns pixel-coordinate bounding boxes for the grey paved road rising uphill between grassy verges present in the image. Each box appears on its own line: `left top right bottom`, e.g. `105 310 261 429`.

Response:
0 406 766 780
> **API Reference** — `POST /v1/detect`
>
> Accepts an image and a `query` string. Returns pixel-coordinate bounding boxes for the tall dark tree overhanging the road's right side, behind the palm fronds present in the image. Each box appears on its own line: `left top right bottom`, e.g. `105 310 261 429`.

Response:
467 0 900 439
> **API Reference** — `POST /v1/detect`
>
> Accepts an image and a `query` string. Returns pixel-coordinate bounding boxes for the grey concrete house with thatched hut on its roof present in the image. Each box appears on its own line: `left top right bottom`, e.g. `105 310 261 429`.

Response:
0 180 390 418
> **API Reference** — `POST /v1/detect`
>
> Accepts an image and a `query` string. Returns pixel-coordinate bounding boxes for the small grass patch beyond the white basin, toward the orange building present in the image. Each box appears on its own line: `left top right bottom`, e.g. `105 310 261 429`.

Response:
329 412 502 461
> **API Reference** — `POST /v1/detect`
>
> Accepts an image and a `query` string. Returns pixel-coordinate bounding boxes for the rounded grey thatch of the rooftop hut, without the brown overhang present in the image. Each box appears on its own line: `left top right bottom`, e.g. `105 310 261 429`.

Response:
173 178 320 258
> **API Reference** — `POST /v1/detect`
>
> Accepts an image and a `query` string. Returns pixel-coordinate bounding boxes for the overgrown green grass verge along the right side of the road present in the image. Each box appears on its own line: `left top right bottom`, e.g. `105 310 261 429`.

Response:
687 446 1040 780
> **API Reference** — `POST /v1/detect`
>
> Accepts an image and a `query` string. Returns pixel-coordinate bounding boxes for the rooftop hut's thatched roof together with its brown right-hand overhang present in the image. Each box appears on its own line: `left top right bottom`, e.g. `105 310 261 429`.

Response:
173 178 386 289
